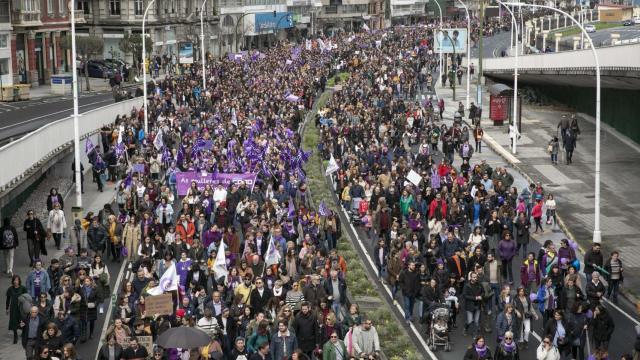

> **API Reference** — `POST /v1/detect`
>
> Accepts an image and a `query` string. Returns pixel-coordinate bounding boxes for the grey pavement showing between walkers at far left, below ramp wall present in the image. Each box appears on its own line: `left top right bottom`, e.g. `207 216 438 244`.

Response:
0 172 121 359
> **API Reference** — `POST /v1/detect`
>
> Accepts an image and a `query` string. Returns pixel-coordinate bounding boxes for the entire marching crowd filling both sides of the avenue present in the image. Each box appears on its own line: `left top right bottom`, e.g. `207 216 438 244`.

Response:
0 14 636 360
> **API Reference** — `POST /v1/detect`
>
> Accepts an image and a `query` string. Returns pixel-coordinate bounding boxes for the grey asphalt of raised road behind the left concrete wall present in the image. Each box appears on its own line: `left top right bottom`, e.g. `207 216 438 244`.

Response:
0 91 114 145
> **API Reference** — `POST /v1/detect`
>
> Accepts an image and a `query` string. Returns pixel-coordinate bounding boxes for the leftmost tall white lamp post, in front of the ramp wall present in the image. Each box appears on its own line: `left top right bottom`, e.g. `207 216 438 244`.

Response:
69 0 82 207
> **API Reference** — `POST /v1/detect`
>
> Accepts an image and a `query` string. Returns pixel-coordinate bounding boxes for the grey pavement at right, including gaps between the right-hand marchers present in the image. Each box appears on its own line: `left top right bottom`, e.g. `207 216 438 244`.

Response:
422 78 640 359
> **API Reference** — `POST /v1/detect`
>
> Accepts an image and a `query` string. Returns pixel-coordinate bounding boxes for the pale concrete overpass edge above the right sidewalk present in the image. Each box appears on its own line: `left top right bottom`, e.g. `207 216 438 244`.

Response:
472 42 640 90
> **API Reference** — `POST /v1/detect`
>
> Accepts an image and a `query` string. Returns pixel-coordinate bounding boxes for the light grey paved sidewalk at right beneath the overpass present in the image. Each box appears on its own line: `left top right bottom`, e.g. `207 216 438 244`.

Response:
437 75 640 302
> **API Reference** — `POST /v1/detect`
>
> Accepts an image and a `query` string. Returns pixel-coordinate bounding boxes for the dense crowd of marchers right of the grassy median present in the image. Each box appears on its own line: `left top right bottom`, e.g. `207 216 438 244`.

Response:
318 19 639 359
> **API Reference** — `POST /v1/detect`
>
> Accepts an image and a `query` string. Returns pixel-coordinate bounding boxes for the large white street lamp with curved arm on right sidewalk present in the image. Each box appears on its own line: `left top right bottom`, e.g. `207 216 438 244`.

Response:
505 2 602 243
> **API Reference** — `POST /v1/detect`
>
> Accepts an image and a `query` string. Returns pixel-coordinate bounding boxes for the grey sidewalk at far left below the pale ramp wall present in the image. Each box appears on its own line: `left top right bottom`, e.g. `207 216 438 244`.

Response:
0 171 117 359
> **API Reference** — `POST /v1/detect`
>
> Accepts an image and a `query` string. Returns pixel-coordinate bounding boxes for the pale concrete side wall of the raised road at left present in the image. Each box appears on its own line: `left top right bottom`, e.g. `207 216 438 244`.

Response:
0 97 142 192
